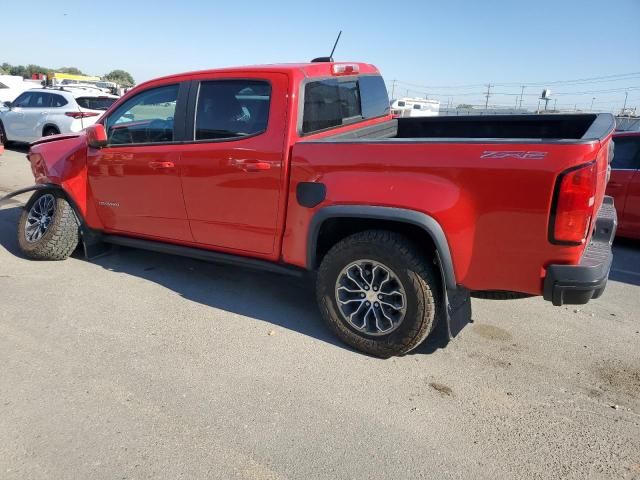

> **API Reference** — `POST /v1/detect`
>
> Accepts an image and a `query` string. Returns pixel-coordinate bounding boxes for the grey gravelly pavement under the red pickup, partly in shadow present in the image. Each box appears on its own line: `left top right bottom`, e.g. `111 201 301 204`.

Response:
0 144 640 479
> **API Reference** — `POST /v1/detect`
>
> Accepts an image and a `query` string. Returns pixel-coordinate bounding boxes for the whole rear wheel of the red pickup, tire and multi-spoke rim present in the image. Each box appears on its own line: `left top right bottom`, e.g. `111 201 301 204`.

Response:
316 230 441 358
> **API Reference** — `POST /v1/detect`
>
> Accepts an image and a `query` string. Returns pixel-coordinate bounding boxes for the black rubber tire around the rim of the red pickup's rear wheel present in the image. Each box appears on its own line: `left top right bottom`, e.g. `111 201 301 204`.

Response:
316 230 442 358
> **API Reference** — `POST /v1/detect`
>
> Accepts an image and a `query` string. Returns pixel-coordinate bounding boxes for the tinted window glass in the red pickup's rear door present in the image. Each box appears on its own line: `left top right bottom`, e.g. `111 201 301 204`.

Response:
194 80 271 140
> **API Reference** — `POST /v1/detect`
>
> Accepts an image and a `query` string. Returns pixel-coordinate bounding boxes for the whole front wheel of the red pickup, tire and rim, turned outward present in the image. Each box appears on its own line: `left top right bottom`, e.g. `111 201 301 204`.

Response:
18 190 79 260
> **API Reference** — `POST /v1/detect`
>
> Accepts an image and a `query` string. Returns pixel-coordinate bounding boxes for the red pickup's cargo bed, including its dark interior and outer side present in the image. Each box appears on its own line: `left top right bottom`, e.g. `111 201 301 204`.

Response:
285 114 615 295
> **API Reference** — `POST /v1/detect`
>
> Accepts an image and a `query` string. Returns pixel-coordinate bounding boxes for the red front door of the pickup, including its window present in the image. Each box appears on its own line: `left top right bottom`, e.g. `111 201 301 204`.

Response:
87 83 192 241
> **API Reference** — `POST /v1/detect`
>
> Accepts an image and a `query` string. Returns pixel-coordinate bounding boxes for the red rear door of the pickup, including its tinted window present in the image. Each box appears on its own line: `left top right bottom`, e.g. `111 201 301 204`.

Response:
182 73 287 258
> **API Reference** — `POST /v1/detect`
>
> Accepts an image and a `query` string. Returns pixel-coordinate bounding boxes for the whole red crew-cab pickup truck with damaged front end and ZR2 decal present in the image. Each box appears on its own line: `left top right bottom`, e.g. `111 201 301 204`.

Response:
2 62 616 357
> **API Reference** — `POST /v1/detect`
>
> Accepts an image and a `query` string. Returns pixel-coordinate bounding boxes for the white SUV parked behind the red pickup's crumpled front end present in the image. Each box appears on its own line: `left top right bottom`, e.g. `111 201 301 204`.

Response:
0 88 118 144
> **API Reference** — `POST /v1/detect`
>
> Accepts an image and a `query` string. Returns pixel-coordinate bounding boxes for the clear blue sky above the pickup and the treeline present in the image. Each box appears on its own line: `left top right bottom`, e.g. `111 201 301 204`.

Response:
0 0 640 110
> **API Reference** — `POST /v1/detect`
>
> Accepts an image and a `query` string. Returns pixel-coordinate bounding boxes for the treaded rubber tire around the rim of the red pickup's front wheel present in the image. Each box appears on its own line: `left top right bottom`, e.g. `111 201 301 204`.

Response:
18 190 79 260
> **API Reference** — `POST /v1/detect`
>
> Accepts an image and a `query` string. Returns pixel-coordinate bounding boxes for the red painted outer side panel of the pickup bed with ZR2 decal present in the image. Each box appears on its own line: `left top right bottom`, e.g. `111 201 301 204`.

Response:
283 140 606 294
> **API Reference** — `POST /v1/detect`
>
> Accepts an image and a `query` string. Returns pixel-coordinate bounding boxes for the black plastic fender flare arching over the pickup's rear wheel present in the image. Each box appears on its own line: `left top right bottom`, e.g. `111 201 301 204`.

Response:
307 205 458 290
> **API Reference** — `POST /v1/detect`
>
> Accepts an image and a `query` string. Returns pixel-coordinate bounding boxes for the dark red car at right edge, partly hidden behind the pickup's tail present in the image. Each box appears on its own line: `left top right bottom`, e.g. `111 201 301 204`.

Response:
607 132 640 239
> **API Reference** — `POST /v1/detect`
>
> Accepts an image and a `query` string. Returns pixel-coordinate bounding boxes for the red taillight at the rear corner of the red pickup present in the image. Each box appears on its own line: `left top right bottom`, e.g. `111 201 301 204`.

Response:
549 162 597 245
